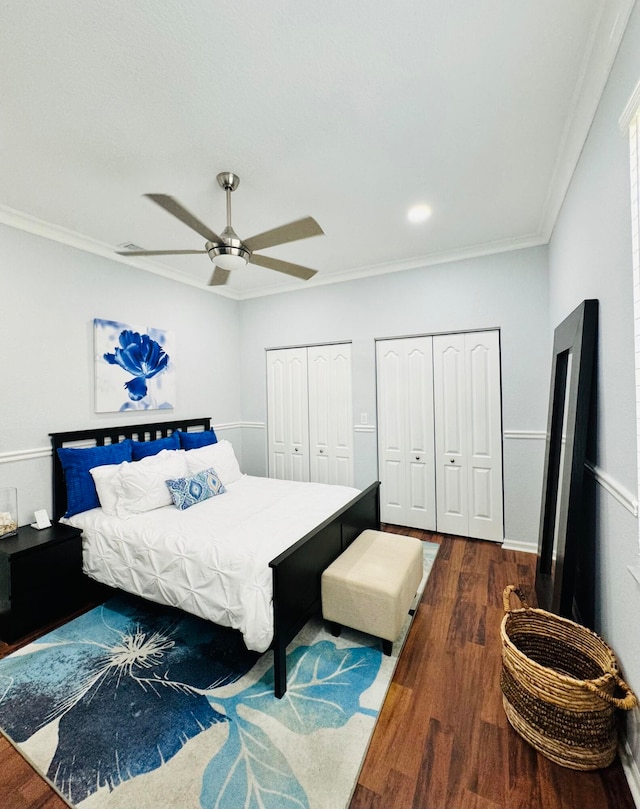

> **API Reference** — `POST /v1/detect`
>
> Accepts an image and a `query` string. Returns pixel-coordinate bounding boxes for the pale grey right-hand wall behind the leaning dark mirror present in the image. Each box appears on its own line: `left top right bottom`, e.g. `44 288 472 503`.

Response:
549 0 640 780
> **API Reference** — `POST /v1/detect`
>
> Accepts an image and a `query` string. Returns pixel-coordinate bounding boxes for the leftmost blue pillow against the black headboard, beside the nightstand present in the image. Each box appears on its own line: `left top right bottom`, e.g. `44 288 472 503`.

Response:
58 438 131 517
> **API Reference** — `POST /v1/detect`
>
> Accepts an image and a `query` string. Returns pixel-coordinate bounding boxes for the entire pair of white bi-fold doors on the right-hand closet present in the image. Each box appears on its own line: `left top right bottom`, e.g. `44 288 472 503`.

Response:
376 330 503 541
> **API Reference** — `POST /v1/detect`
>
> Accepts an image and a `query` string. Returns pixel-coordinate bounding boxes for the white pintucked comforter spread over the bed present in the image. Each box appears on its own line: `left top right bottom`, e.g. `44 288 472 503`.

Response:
64 475 359 652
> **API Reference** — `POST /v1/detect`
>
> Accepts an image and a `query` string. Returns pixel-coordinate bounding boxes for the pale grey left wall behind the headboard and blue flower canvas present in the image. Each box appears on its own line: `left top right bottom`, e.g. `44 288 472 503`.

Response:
0 225 240 524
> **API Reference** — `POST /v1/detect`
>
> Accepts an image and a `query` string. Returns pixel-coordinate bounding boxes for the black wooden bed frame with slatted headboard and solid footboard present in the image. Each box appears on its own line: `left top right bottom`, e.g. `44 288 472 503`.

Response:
50 418 380 698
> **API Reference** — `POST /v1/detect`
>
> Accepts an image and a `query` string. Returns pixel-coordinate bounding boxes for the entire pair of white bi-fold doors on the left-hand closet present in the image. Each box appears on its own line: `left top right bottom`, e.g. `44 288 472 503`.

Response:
267 343 353 486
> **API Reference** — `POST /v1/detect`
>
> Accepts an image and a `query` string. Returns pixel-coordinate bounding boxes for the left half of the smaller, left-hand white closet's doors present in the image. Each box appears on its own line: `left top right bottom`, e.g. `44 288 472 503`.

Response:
267 348 309 481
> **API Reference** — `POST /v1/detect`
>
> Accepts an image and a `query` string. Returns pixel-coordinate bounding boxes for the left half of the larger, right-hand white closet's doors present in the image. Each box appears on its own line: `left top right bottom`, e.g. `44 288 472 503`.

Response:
376 337 436 530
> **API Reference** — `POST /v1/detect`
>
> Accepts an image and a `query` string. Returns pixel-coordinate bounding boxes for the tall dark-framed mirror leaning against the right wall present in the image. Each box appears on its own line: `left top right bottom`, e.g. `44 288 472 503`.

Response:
536 300 598 618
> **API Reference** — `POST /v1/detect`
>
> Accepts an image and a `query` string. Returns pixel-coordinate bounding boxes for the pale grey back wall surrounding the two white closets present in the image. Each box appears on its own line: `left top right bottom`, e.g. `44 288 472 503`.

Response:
240 247 551 549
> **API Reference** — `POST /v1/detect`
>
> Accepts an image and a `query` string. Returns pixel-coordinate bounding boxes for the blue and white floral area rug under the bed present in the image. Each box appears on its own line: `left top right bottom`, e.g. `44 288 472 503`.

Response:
0 543 438 809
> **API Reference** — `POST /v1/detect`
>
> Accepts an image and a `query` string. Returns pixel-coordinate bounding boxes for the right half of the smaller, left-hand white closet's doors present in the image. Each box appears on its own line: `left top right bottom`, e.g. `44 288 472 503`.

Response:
307 343 353 486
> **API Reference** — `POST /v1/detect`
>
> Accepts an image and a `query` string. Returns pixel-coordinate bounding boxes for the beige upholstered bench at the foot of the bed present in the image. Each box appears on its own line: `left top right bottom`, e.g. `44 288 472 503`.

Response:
321 530 422 654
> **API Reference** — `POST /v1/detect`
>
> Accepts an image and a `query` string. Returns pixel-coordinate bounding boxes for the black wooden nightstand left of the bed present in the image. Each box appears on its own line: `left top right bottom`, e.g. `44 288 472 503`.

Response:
0 524 88 642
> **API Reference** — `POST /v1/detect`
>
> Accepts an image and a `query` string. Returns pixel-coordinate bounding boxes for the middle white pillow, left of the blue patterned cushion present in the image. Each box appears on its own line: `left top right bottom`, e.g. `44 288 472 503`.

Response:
113 449 187 518
